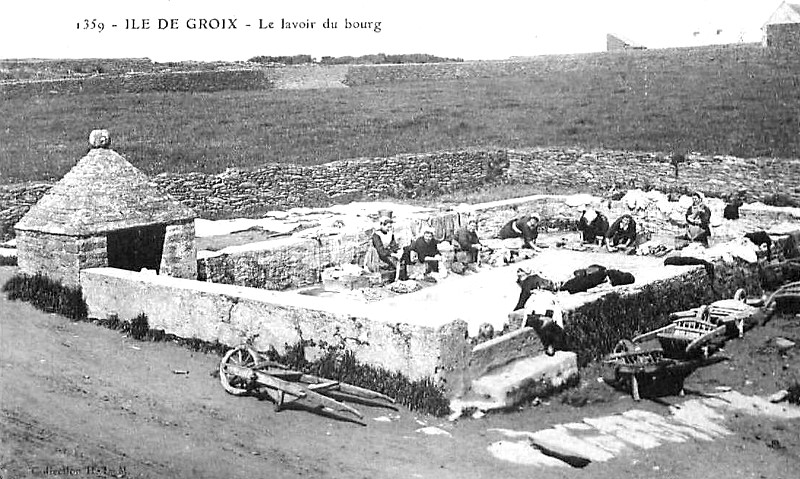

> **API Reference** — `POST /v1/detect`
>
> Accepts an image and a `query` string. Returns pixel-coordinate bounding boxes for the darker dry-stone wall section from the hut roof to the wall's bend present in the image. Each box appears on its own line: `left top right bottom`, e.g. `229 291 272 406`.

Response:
153 151 505 217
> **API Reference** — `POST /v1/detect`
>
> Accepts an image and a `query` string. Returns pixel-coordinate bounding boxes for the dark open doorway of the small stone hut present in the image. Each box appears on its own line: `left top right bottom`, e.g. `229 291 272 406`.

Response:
106 225 167 272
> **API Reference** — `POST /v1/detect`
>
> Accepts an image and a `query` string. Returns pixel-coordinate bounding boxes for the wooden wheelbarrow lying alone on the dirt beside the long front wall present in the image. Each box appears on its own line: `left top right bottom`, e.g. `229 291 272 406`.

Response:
219 346 396 426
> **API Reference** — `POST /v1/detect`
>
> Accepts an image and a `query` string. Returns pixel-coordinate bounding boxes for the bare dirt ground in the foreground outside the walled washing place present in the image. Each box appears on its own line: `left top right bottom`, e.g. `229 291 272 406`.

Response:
0 267 800 479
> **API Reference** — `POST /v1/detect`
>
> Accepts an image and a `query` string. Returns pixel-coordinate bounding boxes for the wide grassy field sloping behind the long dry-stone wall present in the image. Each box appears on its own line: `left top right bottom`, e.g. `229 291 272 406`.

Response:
0 45 800 183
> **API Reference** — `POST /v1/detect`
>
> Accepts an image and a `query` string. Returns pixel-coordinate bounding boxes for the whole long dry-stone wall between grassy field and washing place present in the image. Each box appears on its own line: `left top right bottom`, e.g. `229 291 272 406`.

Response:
0 148 800 242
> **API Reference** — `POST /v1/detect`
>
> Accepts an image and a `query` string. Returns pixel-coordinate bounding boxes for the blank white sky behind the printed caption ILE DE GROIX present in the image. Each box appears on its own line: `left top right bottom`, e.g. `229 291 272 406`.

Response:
0 0 782 62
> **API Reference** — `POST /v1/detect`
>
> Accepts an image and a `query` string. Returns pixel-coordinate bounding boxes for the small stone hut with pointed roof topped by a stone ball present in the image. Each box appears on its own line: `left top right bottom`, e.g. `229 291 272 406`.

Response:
14 130 197 286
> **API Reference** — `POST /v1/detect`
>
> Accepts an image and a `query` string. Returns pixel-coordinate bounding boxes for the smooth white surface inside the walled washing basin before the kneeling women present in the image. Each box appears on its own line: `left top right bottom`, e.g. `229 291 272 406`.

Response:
285 247 692 337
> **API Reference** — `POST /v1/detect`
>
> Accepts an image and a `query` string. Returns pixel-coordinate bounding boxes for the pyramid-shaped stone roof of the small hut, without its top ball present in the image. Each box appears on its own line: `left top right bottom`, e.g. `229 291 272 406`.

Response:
15 149 196 236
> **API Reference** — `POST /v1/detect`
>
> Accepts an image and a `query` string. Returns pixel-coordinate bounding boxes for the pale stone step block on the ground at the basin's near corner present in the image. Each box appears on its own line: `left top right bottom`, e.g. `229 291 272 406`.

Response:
451 351 578 410
